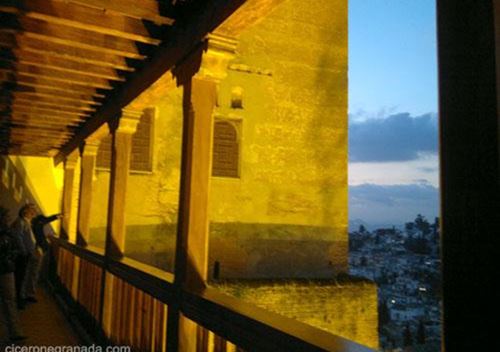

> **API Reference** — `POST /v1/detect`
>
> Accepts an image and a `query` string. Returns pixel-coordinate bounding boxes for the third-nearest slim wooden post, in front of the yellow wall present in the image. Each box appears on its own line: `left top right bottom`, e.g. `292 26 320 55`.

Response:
76 125 109 247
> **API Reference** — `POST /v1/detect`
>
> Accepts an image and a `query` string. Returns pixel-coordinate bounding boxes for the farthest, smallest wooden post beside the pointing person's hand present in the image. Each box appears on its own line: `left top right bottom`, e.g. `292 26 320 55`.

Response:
61 152 79 242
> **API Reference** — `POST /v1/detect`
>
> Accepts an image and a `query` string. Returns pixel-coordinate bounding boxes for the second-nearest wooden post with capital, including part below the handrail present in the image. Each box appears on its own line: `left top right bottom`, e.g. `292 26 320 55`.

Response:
100 109 142 337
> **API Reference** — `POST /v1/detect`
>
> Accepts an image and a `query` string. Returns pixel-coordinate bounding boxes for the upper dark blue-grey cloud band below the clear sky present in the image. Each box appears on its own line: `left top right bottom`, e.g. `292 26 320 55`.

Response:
349 113 438 162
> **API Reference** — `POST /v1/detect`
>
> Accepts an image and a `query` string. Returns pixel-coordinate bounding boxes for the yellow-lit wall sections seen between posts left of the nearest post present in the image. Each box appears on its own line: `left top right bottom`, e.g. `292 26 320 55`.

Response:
91 85 182 270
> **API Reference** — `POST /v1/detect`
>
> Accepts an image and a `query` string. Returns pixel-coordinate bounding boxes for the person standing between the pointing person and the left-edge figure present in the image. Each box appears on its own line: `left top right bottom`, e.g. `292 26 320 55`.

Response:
12 204 42 309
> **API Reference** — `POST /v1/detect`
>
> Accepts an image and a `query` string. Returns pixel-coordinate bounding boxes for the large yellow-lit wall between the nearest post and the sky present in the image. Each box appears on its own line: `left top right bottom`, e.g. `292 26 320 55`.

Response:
210 0 348 277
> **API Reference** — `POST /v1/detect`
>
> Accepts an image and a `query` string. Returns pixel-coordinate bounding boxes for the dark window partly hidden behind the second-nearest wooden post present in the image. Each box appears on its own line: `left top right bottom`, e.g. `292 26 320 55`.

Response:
96 109 154 171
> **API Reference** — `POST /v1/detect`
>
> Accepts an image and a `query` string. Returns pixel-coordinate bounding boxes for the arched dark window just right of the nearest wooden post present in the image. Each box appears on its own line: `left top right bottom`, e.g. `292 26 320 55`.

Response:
212 121 240 177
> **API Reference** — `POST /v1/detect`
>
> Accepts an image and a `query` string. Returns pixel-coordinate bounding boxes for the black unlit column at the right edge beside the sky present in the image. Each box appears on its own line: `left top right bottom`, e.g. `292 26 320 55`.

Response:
437 0 500 351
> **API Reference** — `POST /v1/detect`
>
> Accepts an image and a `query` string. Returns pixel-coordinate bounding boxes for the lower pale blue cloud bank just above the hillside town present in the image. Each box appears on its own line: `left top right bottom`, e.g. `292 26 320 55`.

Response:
349 183 439 225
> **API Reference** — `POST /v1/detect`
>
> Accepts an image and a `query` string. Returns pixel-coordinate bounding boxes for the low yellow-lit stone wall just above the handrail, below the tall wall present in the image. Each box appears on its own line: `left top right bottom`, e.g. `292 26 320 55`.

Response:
214 280 378 349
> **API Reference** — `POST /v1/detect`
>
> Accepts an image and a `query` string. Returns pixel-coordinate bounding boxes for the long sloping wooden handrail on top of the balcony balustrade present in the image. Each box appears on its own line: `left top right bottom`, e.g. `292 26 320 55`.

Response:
52 238 372 352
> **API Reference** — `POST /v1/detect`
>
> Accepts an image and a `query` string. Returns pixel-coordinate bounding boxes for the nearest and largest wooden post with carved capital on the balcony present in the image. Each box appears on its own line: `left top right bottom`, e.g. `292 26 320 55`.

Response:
167 36 236 352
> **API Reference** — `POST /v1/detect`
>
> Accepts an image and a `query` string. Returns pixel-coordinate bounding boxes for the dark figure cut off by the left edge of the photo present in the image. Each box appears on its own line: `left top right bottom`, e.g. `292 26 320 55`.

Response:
0 207 26 342
